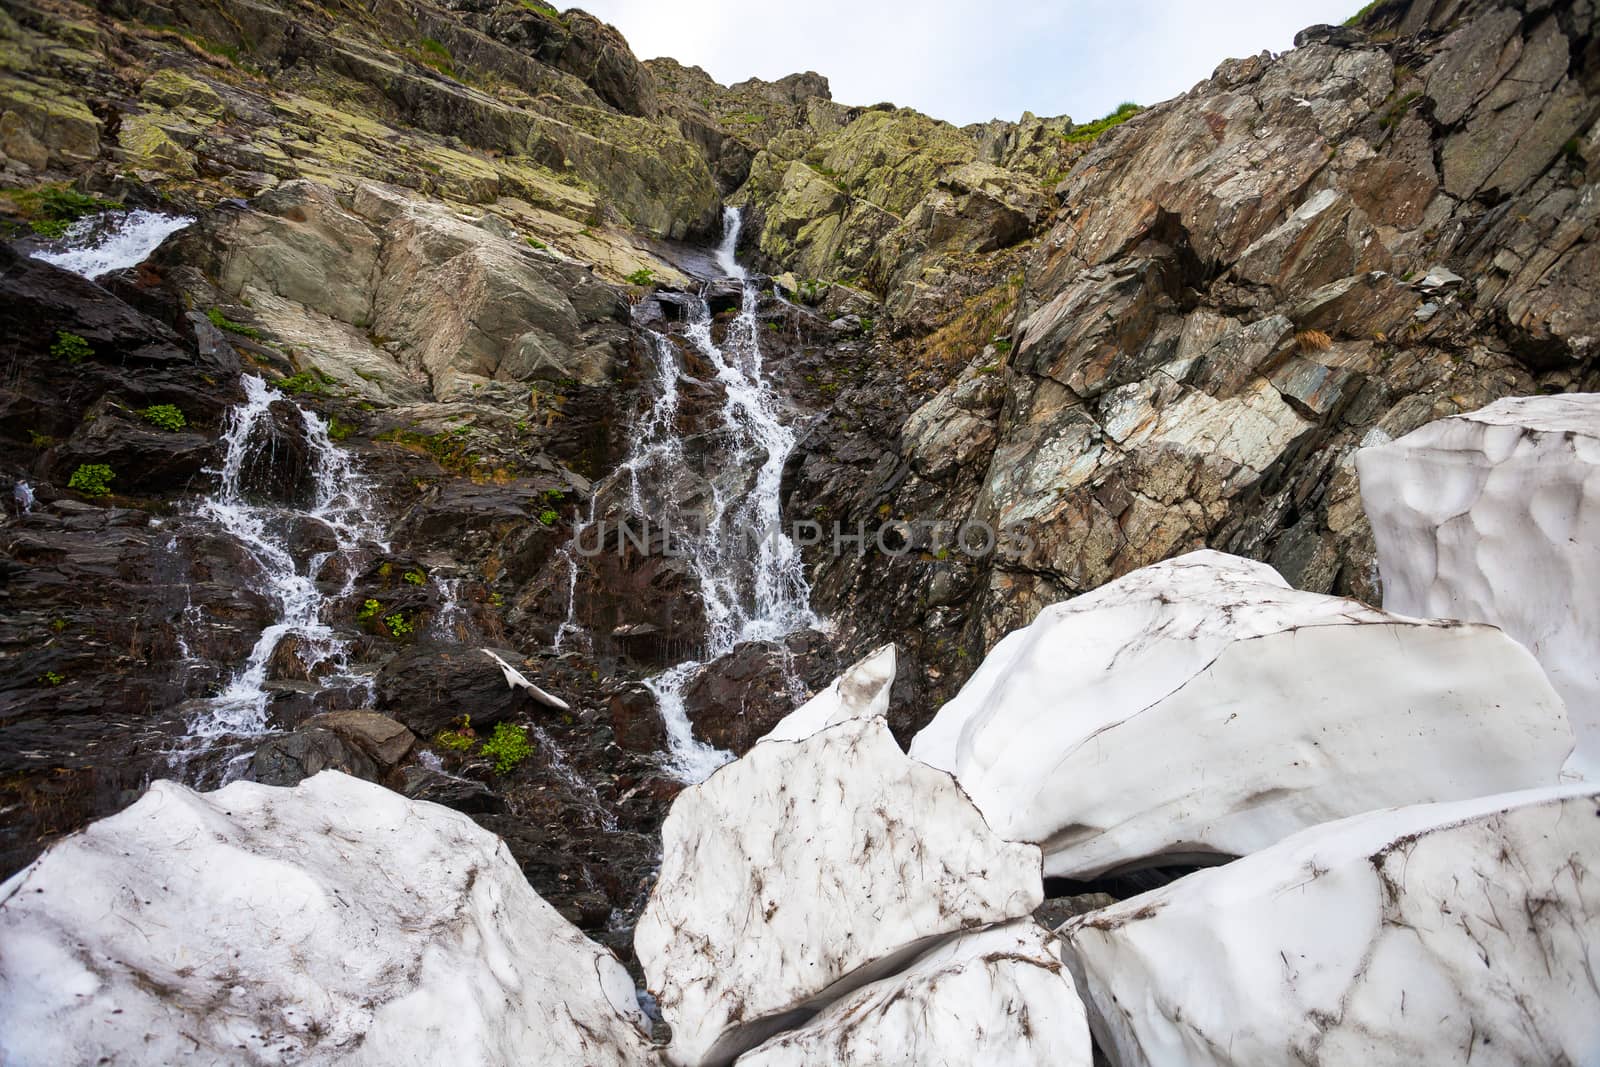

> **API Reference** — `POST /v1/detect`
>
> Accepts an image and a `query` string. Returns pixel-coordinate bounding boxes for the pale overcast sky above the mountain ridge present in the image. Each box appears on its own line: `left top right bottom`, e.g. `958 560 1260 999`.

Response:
582 0 1363 125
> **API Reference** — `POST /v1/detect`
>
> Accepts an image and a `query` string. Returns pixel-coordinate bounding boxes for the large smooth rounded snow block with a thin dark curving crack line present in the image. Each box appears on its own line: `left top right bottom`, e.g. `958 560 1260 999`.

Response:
910 552 1573 878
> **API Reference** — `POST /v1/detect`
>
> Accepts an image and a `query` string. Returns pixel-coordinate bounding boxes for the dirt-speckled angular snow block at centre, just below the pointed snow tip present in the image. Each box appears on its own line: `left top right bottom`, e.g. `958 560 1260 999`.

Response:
634 718 1043 1065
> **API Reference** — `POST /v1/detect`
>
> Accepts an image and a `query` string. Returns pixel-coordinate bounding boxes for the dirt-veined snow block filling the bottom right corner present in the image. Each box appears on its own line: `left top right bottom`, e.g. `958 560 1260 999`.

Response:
1061 784 1600 1067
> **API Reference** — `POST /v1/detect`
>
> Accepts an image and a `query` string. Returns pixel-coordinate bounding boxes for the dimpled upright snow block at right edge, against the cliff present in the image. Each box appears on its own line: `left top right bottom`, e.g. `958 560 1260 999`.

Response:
1355 394 1600 769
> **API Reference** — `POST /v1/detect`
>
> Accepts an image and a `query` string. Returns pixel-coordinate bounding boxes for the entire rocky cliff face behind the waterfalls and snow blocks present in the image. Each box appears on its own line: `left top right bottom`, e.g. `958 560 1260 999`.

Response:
0 0 1600 985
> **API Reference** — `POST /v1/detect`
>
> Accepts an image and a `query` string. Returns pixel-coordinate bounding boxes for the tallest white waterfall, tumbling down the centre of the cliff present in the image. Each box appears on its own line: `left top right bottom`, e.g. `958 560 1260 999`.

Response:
557 208 818 782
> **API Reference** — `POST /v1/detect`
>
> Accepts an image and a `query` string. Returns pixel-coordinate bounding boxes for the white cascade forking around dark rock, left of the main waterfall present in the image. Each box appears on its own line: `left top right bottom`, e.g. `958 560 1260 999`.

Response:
180 374 387 755
